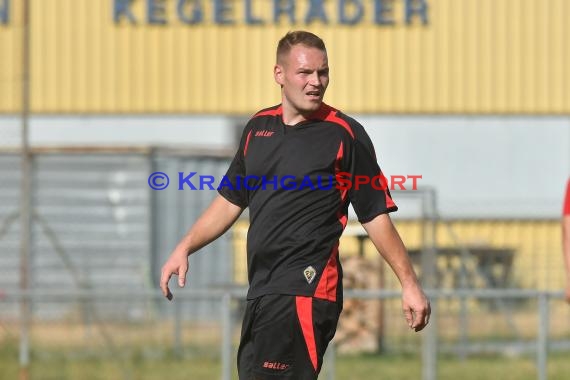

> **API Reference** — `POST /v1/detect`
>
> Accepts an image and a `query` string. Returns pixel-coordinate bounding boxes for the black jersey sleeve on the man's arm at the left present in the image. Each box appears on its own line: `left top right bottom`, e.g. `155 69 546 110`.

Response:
218 126 251 208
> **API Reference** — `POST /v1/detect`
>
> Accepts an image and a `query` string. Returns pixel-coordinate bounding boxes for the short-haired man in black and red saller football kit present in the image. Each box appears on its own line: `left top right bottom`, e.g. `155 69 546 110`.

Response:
161 31 430 380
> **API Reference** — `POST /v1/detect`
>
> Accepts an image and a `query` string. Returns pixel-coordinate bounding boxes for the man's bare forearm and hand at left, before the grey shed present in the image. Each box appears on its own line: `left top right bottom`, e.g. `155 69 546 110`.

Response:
160 195 243 300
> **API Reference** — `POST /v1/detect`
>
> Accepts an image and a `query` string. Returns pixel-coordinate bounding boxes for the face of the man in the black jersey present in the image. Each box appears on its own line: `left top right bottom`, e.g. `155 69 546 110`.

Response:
274 45 329 116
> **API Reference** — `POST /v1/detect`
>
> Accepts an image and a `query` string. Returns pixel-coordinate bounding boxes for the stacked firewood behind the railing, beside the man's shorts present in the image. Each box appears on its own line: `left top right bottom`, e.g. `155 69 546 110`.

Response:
335 256 382 354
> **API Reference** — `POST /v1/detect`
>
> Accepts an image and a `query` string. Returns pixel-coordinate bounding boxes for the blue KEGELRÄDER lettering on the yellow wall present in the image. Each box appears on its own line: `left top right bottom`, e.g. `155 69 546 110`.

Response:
106 0 429 26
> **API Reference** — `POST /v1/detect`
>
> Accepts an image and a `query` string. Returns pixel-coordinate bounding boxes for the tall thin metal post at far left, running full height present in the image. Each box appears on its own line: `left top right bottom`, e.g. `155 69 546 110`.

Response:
19 0 32 380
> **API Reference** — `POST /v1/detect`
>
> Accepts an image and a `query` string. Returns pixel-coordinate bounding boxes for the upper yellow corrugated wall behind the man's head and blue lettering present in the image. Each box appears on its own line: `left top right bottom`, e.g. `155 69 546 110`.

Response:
0 0 570 114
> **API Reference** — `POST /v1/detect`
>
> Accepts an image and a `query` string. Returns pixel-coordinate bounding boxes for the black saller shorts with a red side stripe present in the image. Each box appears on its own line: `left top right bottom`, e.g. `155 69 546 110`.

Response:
234 294 342 380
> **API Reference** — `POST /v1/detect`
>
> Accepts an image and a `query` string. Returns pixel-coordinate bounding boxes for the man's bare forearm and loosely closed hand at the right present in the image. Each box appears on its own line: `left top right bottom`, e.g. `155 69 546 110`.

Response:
362 214 431 331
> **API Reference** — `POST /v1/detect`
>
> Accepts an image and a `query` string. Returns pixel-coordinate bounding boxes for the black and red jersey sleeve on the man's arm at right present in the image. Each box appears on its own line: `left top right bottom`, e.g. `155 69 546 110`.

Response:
349 125 398 223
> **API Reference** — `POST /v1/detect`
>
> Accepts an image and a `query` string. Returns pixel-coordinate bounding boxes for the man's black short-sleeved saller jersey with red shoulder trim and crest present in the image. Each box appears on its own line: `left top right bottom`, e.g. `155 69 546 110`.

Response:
218 103 397 301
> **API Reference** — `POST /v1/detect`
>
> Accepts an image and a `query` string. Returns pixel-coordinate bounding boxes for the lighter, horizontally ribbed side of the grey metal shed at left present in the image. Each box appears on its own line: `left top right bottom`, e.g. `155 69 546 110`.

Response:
14 153 151 318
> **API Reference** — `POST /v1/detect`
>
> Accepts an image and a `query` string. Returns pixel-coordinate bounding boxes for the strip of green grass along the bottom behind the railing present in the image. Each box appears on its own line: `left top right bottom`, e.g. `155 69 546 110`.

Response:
0 342 570 380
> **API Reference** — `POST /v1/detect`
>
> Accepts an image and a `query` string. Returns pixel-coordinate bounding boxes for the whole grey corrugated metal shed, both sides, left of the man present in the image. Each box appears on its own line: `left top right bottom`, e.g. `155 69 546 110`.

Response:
0 153 233 318
